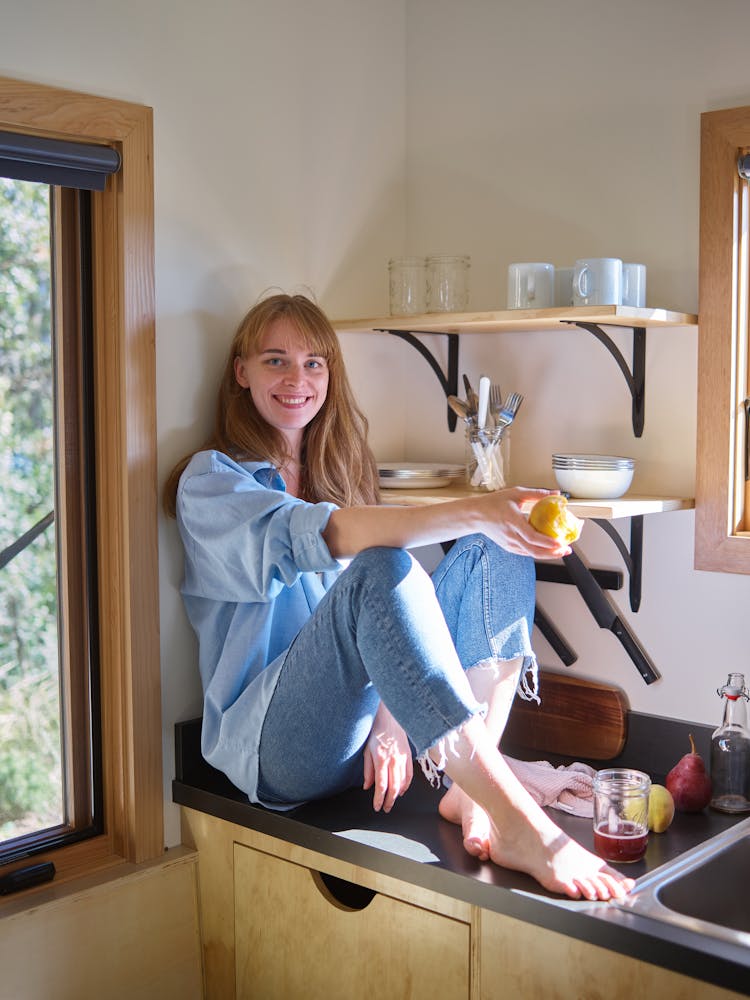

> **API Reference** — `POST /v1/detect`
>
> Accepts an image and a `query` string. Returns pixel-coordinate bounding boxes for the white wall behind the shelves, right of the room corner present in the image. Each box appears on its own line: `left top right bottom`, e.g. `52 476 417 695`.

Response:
396 0 750 736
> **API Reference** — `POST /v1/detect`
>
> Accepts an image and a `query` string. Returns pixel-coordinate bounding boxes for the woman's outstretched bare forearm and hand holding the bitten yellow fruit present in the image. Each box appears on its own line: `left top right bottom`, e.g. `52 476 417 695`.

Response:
323 486 570 559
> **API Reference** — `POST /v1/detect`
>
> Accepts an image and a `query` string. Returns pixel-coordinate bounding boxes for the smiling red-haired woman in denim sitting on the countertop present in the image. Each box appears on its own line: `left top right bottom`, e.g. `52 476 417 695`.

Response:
165 295 632 900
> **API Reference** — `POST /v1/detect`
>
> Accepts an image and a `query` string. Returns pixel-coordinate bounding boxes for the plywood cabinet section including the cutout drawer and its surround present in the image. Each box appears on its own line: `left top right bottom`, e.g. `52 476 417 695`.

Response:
183 809 474 1000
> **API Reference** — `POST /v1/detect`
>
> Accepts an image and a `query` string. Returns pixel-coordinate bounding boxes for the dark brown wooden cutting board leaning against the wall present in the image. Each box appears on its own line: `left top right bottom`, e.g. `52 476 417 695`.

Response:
501 670 630 760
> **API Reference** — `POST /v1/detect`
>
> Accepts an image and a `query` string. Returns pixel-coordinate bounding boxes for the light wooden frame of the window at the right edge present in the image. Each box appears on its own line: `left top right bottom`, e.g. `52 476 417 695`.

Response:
695 107 750 573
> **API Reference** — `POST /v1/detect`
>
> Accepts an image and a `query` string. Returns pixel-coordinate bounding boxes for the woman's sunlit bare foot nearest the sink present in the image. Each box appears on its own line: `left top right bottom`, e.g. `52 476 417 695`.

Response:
490 810 634 900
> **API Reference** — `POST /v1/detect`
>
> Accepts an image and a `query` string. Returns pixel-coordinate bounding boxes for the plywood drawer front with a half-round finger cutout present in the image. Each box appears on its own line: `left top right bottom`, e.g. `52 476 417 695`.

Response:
234 844 470 1000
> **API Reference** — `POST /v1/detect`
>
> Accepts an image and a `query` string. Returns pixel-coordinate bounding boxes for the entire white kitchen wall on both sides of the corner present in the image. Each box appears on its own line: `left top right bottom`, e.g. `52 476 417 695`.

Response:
0 0 750 843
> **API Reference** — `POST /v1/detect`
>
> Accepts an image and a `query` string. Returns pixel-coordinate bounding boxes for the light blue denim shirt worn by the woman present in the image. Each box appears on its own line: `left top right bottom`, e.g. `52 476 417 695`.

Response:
177 451 343 802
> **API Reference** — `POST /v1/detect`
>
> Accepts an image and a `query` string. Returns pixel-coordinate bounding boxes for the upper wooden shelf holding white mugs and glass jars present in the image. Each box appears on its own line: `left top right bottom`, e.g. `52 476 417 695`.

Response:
333 306 698 333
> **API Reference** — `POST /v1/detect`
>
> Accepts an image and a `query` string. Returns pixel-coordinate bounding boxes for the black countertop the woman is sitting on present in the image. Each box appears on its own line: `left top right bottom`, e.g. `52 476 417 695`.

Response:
173 713 750 996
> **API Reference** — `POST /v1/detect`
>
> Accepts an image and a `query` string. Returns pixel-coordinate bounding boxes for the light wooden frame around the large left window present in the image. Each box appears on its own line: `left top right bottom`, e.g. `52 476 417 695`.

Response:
0 79 163 879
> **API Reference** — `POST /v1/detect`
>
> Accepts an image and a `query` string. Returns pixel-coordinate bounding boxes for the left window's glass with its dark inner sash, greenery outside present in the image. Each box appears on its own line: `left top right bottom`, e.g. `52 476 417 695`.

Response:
0 176 102 861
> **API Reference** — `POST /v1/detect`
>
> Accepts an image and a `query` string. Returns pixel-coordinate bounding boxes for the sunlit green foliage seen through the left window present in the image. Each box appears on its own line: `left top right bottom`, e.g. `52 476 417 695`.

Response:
0 178 62 841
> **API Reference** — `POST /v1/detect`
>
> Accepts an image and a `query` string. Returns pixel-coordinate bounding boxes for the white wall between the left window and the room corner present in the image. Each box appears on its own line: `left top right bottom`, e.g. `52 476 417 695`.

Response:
0 0 406 844
